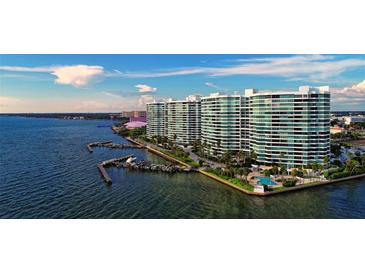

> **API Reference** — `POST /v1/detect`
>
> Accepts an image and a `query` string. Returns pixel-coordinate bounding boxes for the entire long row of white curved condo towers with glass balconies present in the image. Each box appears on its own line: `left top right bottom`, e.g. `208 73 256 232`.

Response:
147 86 330 168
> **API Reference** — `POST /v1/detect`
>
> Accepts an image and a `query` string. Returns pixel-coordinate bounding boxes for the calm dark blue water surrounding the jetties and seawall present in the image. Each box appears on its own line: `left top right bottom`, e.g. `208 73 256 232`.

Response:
0 116 365 218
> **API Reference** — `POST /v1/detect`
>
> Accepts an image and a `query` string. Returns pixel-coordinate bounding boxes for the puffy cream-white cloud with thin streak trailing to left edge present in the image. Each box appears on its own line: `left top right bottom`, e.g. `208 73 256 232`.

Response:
0 65 104 87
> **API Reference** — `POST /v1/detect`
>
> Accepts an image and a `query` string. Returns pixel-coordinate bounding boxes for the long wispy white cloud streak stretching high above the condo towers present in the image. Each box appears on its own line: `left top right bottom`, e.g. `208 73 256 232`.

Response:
108 55 365 80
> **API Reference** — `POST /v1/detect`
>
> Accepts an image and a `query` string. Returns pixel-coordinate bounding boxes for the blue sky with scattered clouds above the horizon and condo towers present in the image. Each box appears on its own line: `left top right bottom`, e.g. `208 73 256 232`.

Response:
0 54 365 112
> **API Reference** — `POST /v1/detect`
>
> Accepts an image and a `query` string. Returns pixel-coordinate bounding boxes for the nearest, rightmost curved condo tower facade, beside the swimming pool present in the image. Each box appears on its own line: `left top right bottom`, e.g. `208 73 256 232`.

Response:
246 87 330 168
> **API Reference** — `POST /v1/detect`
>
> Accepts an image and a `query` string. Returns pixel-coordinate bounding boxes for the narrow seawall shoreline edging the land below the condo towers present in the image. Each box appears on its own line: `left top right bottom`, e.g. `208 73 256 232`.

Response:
124 137 365 197
